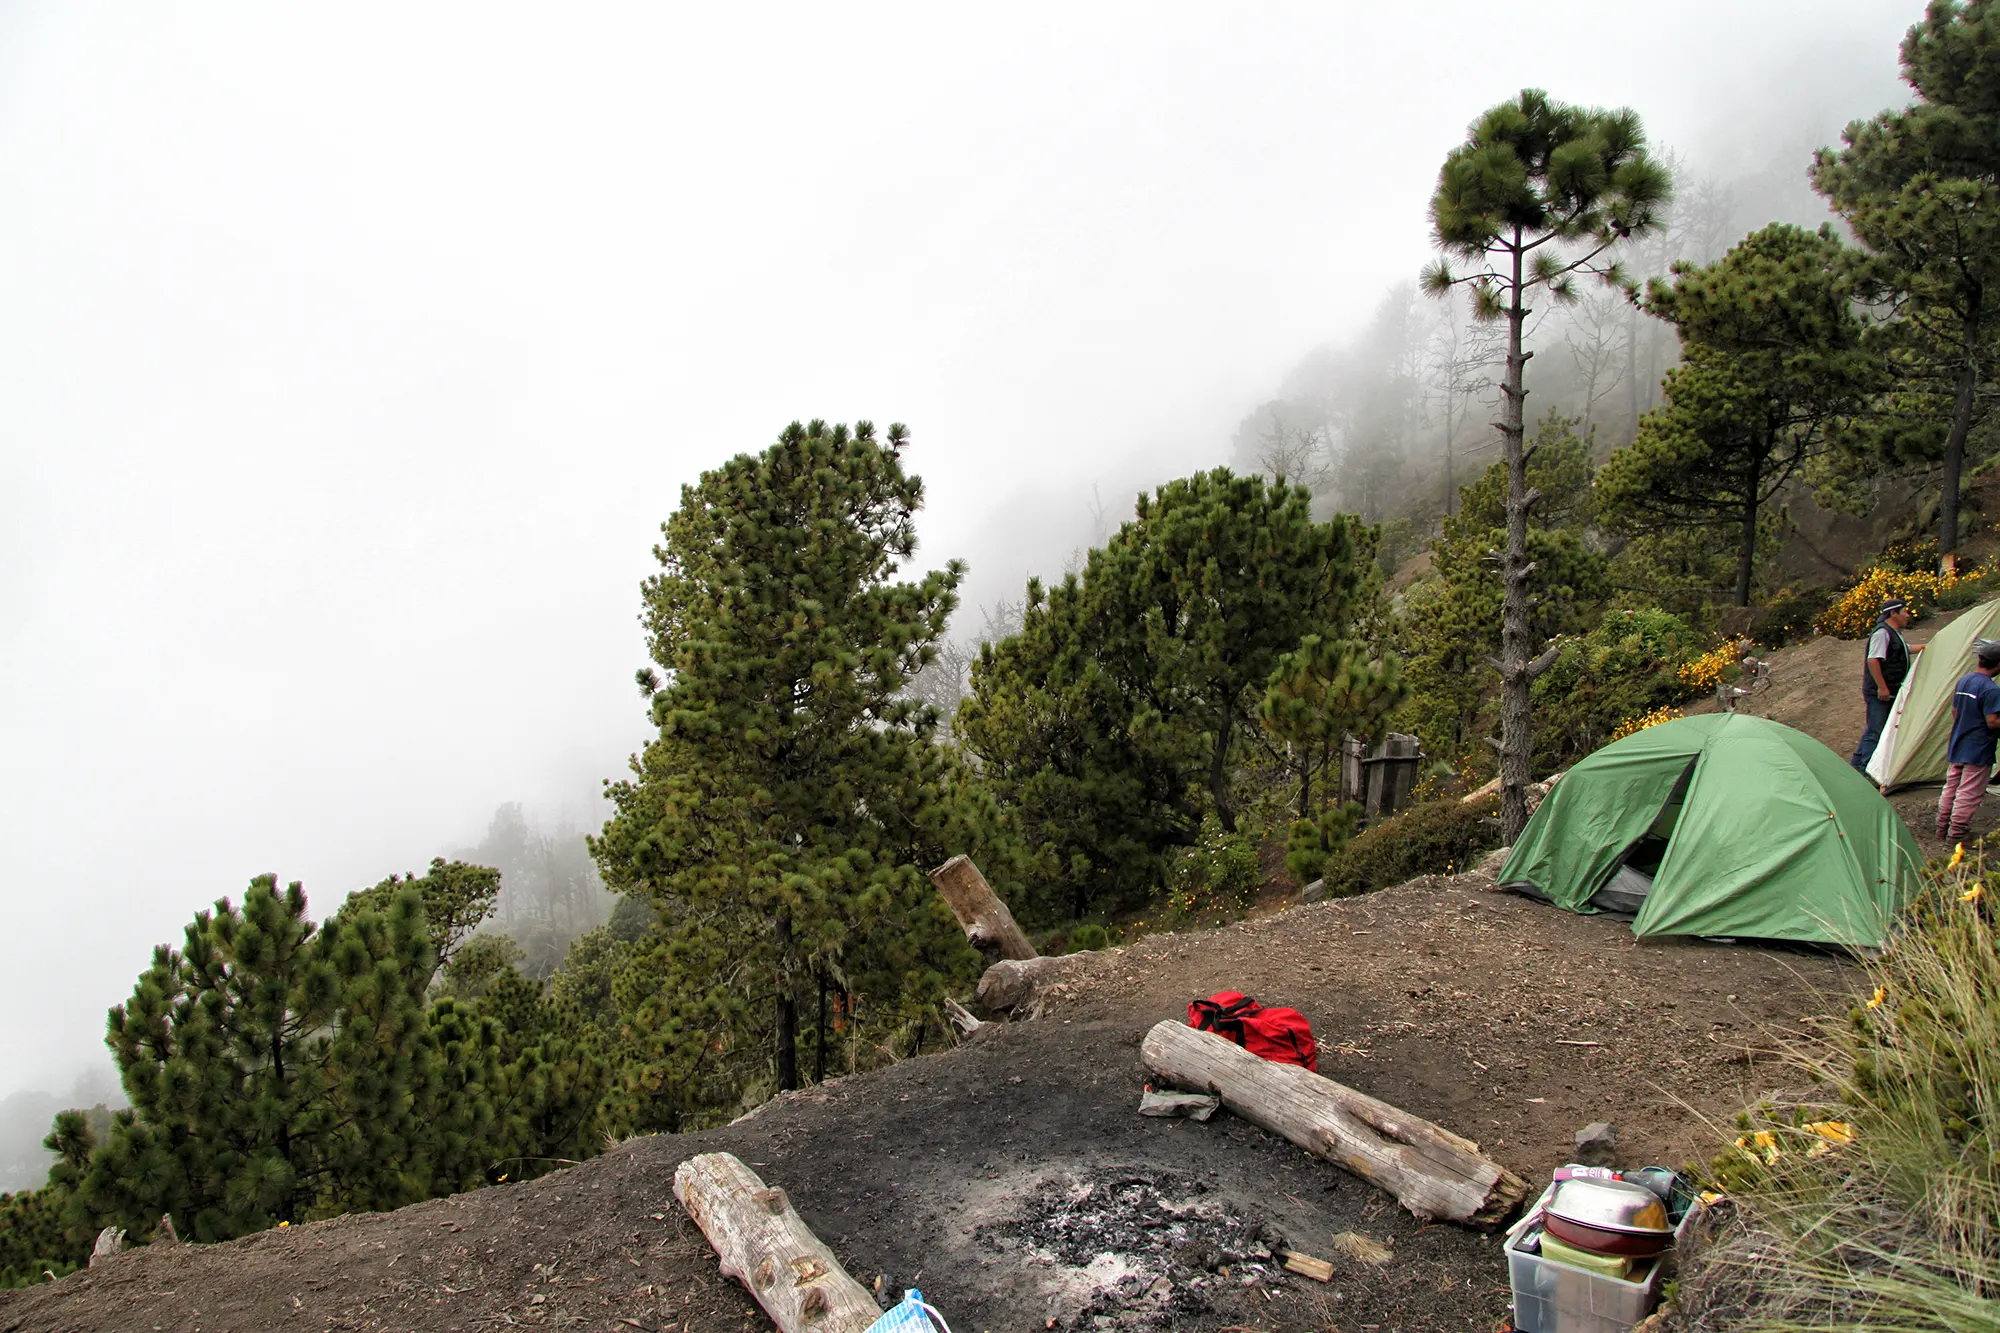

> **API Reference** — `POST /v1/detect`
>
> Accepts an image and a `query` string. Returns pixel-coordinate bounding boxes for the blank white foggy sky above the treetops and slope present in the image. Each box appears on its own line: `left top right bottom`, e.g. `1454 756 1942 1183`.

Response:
0 0 1922 1093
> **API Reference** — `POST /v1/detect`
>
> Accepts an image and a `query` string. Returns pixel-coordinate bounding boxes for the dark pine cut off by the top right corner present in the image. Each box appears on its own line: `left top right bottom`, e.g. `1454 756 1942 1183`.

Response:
1812 0 2000 562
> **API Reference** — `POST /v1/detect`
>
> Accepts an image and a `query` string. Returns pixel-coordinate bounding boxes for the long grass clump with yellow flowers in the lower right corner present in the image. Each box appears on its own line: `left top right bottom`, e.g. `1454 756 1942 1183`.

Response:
1668 857 2000 1333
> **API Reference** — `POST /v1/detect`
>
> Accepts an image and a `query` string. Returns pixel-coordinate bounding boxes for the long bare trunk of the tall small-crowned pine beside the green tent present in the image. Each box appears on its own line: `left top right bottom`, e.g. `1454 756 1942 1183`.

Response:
1500 226 1536 845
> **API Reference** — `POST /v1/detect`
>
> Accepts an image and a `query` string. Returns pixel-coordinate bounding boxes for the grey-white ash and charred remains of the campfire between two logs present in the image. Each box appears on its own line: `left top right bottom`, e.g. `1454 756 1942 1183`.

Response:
976 1167 1286 1329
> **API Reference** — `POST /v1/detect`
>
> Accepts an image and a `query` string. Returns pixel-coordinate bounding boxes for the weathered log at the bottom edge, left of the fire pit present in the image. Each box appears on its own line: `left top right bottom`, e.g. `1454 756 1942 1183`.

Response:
674 1153 882 1333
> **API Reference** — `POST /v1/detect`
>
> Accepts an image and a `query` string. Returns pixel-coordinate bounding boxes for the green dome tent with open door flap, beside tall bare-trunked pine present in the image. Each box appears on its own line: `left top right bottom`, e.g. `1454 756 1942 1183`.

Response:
1500 713 1922 947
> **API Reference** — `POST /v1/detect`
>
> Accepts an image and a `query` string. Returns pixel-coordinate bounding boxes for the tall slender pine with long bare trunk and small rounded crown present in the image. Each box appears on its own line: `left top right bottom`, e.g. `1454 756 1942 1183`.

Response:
1424 88 1670 843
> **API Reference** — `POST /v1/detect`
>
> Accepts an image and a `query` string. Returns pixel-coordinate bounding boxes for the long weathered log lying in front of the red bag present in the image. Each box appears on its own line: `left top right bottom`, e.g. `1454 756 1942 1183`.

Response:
1140 1019 1528 1227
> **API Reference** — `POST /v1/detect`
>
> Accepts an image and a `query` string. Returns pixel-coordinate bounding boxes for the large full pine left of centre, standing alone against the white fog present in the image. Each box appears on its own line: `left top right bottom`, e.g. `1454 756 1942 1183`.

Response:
594 420 970 1101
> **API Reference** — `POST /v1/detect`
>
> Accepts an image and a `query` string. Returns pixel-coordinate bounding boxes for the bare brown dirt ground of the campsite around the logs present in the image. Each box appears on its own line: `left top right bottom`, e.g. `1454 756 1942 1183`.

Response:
0 875 1860 1333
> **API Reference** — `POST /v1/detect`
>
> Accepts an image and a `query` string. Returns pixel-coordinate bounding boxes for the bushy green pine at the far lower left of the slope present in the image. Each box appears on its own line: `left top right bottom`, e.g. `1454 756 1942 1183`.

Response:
82 875 450 1241
